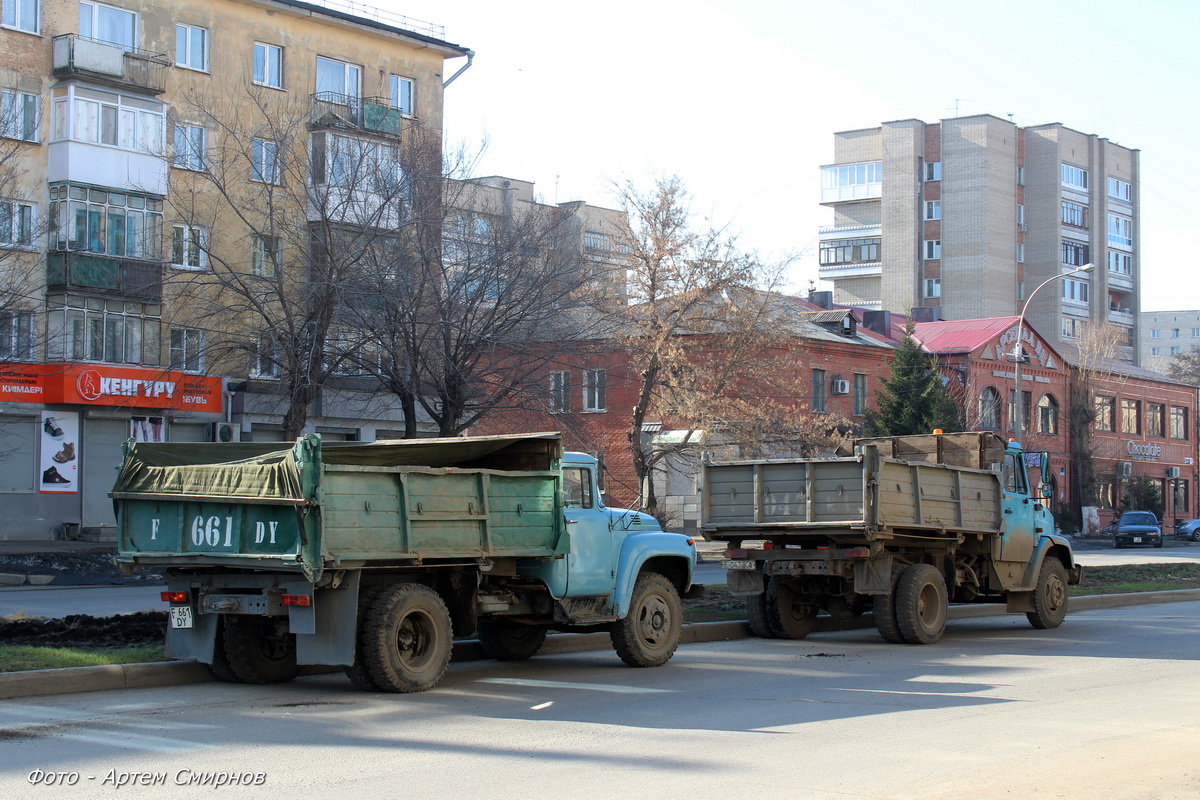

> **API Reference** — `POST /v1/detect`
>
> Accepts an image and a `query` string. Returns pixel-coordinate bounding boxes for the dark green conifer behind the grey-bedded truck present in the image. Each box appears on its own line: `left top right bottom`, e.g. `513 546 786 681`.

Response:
866 319 961 437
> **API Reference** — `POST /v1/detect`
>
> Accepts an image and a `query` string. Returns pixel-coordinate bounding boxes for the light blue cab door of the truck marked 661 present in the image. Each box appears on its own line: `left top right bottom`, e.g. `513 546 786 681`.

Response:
563 463 617 597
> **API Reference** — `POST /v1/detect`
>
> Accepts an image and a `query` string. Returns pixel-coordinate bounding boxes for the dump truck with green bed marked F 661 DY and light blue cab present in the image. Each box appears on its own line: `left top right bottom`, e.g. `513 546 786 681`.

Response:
112 433 702 692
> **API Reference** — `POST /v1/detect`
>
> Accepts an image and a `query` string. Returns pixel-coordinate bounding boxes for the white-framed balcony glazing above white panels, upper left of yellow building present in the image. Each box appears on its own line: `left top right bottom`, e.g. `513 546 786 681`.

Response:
52 84 167 156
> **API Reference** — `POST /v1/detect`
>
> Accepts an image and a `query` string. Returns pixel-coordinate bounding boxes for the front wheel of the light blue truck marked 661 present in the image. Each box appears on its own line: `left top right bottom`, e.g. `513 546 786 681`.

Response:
608 572 683 667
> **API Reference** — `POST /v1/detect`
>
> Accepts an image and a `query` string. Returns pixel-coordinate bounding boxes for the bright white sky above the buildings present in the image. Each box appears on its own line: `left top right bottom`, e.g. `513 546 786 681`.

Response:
372 0 1200 311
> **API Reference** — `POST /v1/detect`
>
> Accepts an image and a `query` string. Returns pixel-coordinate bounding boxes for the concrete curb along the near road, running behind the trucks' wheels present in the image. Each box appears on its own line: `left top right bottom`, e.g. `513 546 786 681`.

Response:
0 589 1200 699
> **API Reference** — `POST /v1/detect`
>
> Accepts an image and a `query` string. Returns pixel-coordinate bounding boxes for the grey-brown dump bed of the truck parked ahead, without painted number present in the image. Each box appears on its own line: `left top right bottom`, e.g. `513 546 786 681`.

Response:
702 433 1004 539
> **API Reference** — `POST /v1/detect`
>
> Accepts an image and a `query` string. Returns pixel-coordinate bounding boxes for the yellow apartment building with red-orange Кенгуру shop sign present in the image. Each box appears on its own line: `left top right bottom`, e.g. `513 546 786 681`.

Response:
0 0 470 539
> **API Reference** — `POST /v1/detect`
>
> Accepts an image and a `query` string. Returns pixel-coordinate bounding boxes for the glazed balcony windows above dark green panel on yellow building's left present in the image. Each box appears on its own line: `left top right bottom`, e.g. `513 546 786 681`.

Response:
49 184 163 256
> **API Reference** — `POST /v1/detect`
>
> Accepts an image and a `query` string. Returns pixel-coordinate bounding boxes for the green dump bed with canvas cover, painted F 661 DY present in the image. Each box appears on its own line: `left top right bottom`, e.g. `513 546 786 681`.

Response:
113 434 568 579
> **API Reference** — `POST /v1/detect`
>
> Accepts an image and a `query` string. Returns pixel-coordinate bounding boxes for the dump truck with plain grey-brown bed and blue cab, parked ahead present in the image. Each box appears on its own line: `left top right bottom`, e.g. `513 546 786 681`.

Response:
702 433 1081 644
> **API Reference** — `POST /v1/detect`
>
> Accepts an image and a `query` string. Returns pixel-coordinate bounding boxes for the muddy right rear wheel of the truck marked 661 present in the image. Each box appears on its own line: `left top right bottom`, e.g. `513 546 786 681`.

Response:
362 583 454 692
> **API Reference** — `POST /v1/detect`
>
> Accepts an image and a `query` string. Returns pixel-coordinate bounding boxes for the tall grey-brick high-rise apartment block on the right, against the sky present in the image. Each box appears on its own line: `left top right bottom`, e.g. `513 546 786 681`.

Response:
820 115 1139 360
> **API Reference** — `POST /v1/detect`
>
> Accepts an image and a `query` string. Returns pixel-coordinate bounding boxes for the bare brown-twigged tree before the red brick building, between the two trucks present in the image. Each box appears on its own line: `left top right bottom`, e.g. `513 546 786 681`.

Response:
616 178 839 513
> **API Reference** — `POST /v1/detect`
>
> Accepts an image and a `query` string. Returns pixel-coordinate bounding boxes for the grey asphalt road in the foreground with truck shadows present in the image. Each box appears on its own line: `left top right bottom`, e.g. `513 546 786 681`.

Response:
0 602 1200 800
